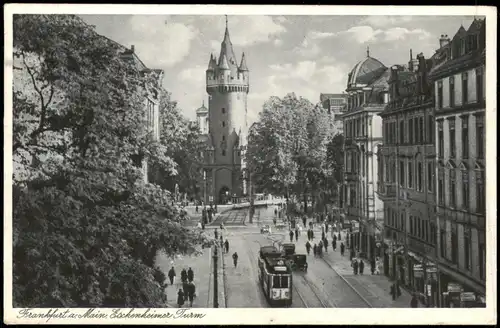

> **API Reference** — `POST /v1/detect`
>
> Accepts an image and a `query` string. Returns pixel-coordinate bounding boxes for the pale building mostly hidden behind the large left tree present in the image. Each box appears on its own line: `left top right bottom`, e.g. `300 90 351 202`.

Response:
120 45 164 183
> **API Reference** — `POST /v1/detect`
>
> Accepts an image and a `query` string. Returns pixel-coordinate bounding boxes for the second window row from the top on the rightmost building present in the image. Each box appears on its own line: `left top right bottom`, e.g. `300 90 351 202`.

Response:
437 114 485 159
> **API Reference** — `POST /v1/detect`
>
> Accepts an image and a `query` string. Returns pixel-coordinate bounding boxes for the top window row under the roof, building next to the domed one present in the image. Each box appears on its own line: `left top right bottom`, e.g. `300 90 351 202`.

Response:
384 115 434 145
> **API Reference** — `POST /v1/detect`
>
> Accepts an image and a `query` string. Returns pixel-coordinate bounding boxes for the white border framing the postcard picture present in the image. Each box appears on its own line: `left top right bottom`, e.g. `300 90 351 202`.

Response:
4 4 497 325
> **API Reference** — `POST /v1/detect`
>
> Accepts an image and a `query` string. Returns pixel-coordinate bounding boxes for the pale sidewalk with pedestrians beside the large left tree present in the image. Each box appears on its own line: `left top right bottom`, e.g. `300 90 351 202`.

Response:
156 248 225 308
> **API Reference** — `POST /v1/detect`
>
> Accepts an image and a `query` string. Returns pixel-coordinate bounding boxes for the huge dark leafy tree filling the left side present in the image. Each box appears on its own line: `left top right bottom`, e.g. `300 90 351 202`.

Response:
13 15 203 307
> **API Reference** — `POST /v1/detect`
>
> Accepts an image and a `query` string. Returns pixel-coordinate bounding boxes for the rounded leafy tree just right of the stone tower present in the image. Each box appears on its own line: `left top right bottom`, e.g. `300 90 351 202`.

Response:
247 93 341 211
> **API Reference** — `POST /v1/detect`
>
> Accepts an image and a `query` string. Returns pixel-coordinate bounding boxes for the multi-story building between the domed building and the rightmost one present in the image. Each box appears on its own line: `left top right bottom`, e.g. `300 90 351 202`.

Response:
377 50 438 305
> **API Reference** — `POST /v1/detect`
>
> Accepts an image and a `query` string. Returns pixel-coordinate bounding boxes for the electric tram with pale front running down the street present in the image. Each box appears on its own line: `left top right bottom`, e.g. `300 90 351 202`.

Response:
259 246 292 306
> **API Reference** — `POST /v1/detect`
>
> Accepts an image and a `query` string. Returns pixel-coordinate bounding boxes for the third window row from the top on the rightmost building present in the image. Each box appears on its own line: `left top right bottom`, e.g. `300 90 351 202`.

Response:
438 168 486 213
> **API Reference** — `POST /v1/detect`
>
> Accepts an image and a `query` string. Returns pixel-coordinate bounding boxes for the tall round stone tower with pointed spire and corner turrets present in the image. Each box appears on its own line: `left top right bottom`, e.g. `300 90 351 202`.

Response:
205 17 249 204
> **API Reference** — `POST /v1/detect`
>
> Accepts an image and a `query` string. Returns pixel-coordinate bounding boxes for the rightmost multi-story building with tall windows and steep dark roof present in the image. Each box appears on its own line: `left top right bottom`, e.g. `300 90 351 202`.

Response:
430 19 486 306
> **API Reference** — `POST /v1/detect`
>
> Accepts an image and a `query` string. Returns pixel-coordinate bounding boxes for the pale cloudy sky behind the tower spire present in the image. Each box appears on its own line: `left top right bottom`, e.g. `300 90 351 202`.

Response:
80 15 473 124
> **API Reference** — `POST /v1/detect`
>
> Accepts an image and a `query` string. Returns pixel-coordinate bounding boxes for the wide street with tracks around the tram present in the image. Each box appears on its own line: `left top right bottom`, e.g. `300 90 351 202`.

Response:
209 206 410 308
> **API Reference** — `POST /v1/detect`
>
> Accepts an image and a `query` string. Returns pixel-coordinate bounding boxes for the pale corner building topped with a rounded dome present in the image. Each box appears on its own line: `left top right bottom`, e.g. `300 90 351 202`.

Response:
342 52 390 258
